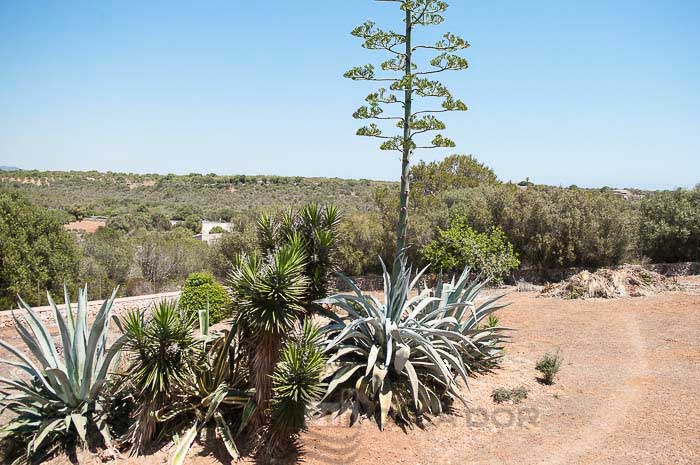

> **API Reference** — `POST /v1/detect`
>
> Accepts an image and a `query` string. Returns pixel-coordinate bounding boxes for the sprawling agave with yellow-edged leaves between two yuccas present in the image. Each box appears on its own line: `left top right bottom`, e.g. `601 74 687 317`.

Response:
167 308 255 465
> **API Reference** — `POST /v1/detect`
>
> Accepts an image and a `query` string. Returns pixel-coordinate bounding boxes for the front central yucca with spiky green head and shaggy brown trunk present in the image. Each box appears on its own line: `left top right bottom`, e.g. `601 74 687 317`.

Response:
229 242 308 426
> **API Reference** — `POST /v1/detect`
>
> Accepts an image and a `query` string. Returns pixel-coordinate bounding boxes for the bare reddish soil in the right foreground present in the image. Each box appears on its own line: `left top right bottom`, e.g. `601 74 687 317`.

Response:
24 278 700 465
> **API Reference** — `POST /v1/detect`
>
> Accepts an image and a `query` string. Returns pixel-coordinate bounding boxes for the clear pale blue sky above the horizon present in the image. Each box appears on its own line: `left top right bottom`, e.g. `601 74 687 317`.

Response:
0 0 700 188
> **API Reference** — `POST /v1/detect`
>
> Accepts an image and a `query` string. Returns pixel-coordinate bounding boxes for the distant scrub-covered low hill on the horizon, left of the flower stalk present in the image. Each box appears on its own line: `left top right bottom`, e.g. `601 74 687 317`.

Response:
0 170 398 220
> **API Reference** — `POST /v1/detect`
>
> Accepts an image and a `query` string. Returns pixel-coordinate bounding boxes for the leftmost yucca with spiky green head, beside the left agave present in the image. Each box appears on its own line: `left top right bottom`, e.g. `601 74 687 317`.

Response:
120 300 201 452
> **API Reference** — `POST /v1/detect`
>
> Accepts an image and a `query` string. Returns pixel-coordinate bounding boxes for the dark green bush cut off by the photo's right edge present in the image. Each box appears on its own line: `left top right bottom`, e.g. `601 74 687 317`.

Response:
639 189 700 262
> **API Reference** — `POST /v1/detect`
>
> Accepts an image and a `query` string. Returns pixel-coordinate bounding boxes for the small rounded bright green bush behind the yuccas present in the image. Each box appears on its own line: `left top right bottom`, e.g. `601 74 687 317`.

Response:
180 273 231 324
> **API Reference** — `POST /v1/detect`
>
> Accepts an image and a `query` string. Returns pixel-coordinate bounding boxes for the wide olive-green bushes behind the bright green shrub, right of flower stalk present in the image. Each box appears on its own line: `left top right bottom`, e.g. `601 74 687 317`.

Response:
442 184 638 268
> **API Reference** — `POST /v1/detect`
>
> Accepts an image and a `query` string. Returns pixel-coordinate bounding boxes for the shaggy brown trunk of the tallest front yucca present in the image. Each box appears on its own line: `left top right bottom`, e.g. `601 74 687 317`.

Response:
250 333 282 428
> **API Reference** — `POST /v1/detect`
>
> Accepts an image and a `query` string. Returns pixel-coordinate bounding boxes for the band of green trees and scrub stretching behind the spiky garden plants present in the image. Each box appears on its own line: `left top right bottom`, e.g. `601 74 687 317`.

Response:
0 160 700 308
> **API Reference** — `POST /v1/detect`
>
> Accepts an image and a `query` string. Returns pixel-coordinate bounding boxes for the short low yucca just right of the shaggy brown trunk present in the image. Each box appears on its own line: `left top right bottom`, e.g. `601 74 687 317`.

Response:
270 318 326 445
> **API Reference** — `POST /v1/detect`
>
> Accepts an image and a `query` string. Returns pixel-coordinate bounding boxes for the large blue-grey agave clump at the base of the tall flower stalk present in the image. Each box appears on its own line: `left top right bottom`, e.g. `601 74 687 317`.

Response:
321 255 505 429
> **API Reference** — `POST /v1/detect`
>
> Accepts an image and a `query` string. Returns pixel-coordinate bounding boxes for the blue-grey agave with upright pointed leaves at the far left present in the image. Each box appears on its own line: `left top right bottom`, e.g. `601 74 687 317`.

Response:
0 287 125 460
